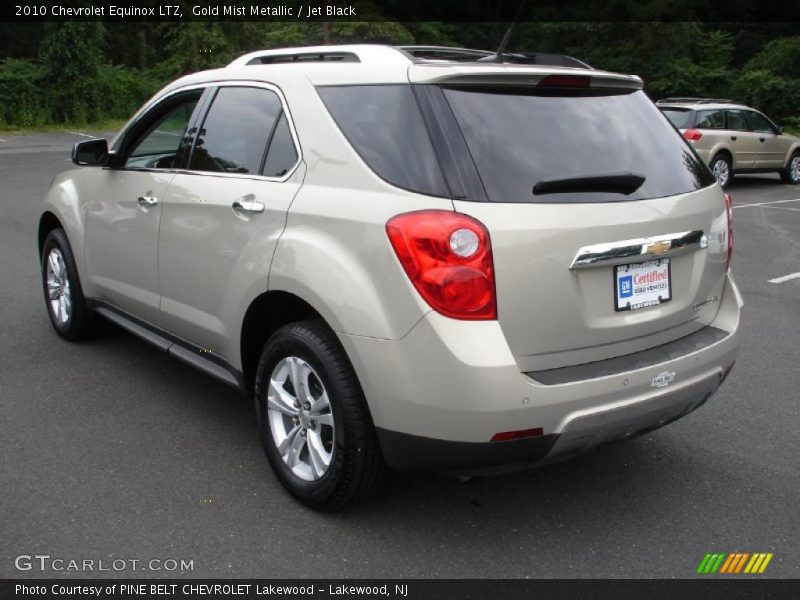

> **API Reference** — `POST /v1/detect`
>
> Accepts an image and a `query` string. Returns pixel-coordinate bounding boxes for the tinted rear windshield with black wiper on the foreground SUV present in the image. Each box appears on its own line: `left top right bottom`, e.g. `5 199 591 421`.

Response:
445 88 714 202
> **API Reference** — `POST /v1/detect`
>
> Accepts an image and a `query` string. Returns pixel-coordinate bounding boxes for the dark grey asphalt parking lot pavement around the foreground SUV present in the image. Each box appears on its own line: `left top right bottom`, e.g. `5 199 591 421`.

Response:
0 132 800 578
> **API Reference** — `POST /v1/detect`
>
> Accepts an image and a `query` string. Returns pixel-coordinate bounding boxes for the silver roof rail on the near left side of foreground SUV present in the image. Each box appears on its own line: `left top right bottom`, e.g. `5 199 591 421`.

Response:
228 44 412 67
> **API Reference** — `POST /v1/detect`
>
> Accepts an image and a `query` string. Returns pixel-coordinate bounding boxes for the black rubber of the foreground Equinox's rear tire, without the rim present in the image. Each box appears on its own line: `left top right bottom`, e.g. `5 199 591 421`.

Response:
255 320 387 510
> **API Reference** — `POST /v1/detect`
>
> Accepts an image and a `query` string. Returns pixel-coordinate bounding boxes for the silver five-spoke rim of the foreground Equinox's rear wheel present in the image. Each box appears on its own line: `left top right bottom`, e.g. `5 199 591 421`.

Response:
267 356 336 481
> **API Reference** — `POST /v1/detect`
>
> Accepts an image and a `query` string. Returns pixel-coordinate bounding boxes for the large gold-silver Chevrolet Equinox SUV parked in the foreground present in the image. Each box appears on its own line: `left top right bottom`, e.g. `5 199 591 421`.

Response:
38 46 742 509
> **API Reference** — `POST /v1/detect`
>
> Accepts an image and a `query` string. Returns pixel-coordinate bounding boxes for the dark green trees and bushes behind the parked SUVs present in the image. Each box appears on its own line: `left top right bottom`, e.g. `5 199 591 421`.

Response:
0 22 800 127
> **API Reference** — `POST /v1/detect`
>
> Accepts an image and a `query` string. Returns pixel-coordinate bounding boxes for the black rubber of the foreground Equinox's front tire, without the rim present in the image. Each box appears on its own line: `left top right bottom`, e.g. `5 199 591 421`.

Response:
41 229 96 342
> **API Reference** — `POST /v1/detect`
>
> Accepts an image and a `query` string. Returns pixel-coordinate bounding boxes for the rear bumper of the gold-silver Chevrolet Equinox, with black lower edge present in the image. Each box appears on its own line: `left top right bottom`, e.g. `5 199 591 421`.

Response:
340 279 742 473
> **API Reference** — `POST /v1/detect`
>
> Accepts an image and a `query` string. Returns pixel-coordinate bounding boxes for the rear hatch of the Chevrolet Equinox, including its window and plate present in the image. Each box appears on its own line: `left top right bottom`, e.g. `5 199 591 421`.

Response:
412 67 727 371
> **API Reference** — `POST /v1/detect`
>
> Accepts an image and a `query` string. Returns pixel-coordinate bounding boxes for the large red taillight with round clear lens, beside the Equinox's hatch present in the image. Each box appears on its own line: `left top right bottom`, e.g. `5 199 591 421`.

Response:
386 210 497 320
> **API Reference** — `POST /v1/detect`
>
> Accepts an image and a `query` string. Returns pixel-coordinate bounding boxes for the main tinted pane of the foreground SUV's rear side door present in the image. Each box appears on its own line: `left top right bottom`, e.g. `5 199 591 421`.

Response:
189 87 282 174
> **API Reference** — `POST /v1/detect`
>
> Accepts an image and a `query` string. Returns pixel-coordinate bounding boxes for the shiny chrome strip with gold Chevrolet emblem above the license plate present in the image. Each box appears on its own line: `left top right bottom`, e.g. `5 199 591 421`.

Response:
569 230 708 271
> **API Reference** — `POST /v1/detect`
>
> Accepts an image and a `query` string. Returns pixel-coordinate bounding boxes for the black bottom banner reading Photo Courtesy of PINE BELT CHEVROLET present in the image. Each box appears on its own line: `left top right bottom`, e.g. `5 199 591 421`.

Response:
0 578 800 600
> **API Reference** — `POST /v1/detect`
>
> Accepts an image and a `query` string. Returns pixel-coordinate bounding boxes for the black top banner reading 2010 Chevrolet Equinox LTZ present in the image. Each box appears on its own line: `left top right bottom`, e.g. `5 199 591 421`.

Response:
0 0 800 23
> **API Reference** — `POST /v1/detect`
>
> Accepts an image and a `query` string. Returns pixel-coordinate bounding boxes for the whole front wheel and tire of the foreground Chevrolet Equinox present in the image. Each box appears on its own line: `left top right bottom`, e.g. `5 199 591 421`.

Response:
42 229 95 342
